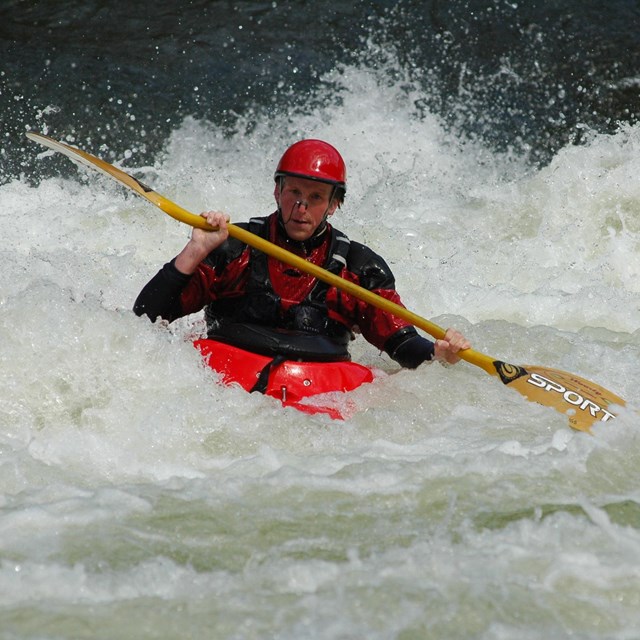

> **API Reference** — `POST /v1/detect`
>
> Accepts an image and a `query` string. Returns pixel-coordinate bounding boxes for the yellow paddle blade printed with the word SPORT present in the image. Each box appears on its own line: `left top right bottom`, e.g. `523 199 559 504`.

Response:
495 361 625 432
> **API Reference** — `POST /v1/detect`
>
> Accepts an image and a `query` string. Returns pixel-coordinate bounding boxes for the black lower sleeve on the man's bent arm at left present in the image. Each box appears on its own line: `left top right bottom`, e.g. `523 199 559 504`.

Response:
133 259 191 322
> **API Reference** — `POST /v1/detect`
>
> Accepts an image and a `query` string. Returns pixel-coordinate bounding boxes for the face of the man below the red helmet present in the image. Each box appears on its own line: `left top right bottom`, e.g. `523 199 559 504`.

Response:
274 176 338 242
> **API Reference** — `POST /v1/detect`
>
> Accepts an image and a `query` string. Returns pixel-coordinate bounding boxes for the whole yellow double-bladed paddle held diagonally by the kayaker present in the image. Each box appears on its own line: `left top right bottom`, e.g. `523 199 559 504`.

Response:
27 132 625 431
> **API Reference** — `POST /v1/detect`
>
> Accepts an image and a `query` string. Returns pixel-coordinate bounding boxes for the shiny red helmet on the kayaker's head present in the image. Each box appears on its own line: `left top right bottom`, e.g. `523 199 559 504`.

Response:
274 140 347 197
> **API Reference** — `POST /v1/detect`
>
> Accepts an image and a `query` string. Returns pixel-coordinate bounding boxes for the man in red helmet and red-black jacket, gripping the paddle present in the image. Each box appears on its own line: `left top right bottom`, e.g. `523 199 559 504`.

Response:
134 139 471 368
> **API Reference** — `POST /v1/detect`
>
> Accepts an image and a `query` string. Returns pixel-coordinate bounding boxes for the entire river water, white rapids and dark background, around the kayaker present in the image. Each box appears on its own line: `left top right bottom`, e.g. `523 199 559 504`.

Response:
0 0 640 640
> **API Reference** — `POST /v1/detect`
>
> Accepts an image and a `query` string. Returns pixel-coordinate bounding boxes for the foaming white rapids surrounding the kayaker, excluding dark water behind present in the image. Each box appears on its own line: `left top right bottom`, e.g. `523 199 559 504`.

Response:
0 58 640 638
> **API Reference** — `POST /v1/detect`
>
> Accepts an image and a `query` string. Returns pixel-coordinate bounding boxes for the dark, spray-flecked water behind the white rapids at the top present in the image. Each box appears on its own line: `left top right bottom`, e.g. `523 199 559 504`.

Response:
0 0 640 181
